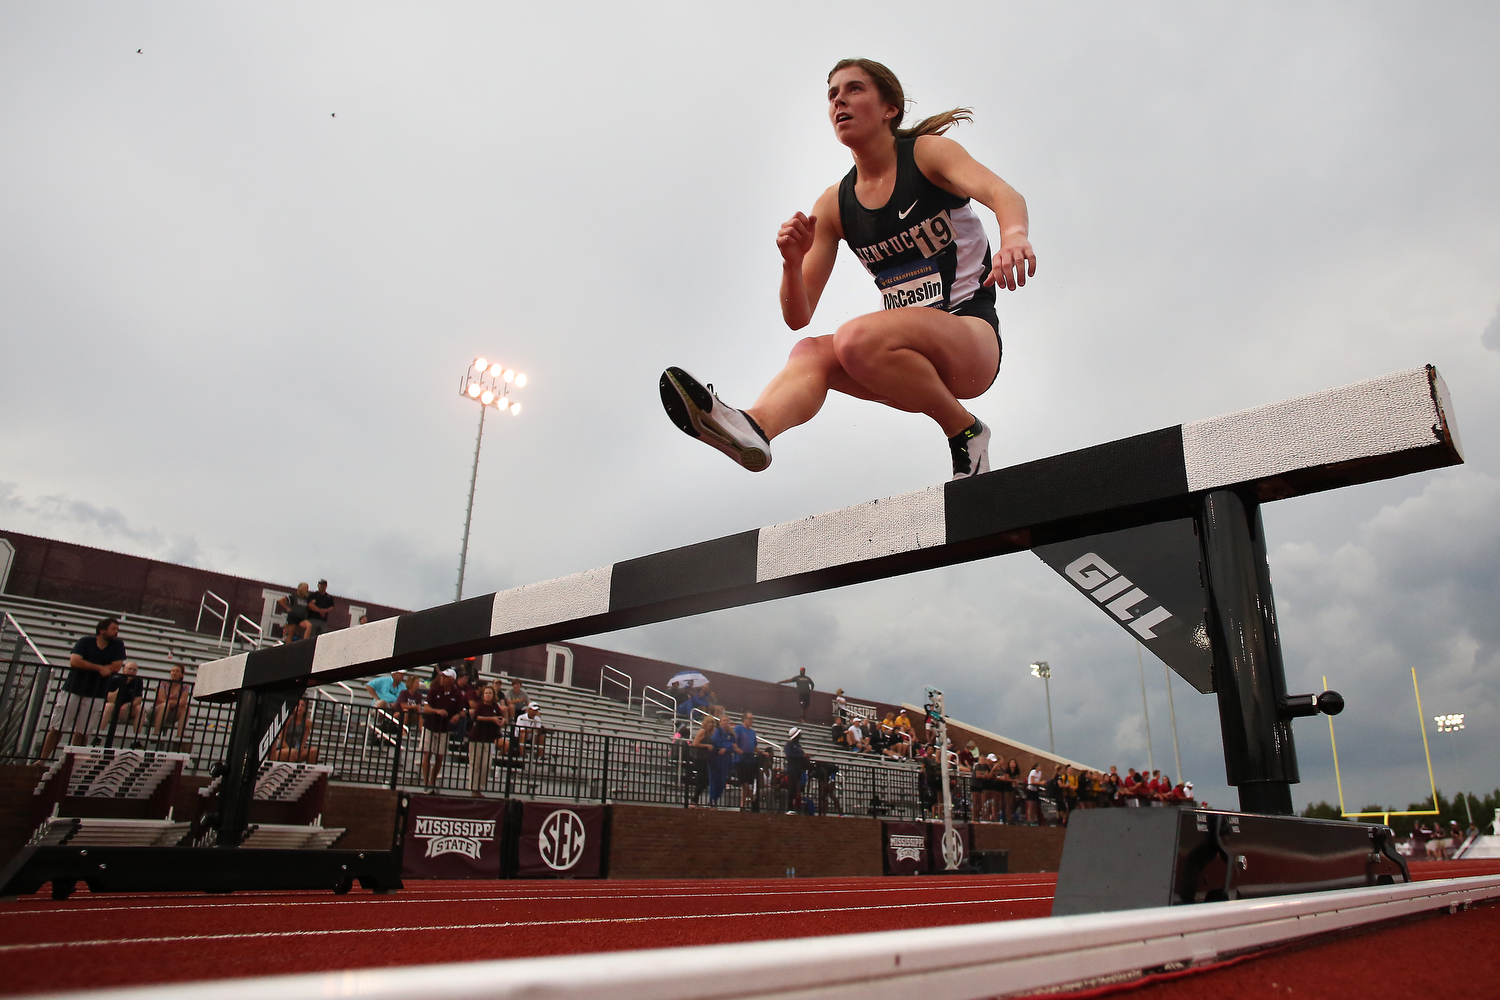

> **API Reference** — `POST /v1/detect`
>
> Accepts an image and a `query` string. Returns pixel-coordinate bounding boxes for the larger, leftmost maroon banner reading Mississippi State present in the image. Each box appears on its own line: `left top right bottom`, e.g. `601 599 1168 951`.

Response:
401 795 506 879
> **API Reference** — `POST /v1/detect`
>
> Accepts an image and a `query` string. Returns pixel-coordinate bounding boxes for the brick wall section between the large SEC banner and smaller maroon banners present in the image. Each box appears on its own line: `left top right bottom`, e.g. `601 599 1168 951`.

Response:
609 805 882 879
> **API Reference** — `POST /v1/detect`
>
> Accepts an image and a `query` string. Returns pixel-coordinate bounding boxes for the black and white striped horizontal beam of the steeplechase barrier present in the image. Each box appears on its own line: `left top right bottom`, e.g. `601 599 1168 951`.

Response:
194 366 1463 700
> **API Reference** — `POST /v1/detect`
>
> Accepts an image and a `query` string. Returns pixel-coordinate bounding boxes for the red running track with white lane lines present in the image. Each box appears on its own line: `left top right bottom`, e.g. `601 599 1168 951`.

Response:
0 862 1500 996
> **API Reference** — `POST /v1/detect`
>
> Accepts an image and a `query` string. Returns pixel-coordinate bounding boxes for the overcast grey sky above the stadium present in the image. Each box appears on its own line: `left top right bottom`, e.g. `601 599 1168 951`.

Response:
0 0 1500 808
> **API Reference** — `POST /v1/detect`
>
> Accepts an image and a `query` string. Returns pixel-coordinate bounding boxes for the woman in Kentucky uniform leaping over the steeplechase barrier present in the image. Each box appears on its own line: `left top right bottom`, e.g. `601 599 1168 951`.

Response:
660 58 1037 478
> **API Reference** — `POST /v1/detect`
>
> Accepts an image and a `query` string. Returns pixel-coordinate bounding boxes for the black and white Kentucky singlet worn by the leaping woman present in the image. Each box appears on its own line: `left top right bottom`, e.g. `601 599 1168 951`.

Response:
839 136 1001 333
